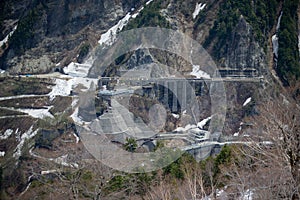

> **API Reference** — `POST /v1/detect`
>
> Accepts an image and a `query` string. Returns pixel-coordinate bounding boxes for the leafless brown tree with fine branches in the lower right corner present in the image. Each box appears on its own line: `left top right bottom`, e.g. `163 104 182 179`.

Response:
222 95 300 199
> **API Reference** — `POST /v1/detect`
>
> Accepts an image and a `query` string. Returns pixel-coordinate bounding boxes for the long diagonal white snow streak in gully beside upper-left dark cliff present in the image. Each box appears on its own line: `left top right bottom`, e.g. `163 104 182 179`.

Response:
98 13 131 46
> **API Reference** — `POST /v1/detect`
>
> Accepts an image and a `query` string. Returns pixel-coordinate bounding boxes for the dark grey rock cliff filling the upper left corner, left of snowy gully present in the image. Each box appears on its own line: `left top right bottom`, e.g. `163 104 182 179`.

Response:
0 0 144 73
